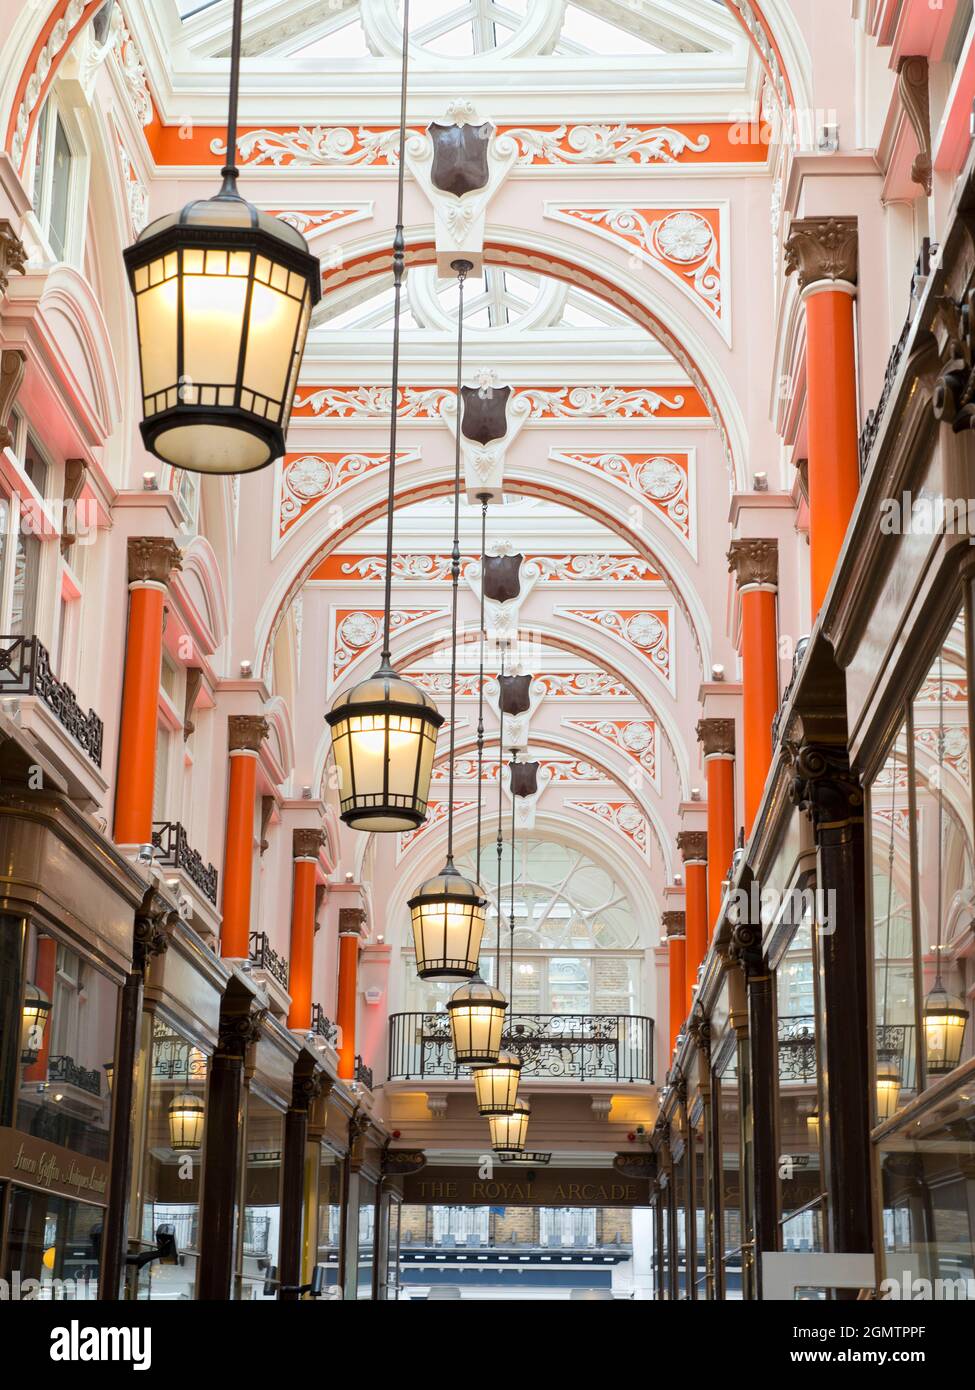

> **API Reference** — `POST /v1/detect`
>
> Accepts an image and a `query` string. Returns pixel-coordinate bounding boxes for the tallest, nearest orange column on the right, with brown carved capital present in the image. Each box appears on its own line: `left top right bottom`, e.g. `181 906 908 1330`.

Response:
786 217 860 619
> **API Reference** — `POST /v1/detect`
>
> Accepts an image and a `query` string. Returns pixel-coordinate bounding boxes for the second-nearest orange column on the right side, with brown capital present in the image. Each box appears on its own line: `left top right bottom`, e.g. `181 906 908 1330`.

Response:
729 539 779 835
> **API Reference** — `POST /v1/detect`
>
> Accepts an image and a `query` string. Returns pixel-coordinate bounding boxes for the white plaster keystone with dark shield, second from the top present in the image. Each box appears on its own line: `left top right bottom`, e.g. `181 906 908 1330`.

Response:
440 368 533 503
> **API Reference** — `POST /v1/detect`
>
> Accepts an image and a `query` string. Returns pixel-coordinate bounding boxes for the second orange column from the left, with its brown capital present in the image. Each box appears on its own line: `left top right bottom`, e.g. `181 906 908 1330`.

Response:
220 714 268 960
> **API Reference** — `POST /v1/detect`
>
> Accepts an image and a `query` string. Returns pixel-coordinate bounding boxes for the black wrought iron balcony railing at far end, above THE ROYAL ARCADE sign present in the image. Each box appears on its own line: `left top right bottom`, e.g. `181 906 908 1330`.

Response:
389 1013 654 1081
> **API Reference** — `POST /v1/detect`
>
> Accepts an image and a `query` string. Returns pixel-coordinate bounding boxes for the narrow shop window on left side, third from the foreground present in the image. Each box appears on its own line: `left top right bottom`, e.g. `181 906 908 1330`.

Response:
238 1091 284 1300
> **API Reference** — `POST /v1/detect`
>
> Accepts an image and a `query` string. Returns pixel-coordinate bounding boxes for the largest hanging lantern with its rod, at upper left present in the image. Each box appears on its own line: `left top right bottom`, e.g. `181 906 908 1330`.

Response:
124 0 321 474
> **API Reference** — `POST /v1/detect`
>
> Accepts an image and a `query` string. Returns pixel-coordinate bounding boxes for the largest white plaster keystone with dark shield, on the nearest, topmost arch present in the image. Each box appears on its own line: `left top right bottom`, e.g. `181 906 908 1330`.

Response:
406 99 517 279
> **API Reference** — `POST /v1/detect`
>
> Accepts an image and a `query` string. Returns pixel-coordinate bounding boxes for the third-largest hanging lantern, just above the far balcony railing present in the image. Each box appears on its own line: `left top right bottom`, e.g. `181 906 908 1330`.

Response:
409 859 487 980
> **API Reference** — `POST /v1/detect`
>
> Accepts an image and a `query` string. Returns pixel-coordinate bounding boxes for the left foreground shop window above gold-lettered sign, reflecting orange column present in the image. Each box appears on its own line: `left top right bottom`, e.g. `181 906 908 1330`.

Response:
12 924 118 1161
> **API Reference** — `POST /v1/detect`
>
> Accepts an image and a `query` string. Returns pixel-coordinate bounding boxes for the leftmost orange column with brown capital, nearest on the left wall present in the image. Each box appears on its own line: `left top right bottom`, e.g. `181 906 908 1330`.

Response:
114 535 179 845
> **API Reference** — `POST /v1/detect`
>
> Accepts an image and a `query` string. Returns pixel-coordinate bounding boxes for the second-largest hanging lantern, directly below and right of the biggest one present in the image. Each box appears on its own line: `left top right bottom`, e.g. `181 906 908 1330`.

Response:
325 662 444 831
